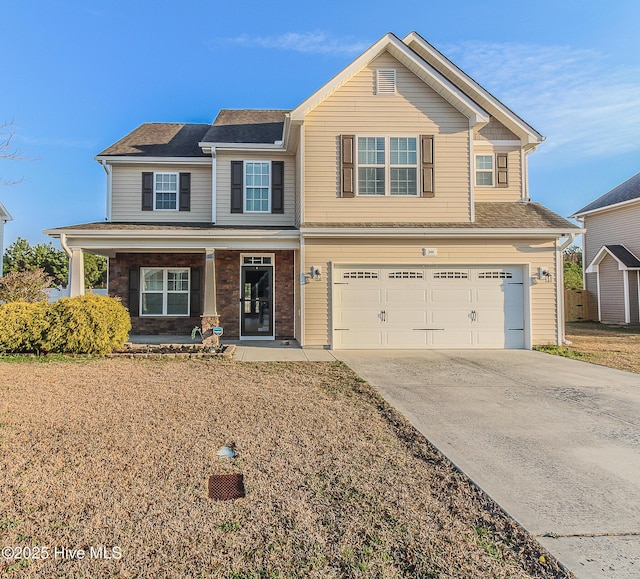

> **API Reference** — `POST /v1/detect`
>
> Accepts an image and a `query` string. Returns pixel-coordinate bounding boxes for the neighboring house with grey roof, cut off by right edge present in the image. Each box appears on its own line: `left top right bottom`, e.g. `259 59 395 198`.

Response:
572 173 640 324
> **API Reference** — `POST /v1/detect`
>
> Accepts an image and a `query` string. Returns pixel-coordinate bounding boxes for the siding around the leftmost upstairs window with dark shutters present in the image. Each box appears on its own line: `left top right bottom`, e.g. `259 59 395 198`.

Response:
111 164 211 223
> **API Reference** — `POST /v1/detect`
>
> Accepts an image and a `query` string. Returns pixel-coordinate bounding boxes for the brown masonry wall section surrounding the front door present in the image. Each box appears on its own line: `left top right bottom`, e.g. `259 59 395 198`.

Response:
216 250 295 341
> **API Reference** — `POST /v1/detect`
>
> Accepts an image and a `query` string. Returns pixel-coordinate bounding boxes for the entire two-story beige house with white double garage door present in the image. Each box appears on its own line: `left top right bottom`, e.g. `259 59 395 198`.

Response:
47 33 581 348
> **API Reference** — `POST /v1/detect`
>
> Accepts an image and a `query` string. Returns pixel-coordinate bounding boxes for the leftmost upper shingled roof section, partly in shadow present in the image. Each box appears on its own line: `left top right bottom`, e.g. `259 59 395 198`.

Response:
98 123 211 157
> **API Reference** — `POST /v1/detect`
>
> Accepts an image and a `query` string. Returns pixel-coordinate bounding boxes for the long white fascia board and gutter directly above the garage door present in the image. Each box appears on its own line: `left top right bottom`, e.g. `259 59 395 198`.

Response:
300 227 583 239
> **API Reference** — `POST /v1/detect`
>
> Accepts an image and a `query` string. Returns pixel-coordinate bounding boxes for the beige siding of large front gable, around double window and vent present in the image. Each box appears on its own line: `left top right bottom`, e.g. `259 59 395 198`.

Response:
303 53 470 223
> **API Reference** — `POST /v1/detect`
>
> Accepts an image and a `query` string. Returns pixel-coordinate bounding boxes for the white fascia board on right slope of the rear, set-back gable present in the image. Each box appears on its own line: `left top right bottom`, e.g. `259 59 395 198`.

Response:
402 32 545 145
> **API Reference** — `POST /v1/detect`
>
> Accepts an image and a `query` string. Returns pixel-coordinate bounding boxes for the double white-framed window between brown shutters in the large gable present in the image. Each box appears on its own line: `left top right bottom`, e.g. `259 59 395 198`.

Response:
357 137 418 195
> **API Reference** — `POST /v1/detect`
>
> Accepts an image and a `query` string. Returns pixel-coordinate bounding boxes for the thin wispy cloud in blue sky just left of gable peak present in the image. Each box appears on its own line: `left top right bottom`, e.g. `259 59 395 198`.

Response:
221 32 371 56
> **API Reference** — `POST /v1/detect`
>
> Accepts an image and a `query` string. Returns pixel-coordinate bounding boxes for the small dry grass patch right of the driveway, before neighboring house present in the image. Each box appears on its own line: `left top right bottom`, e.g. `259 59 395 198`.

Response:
566 322 640 373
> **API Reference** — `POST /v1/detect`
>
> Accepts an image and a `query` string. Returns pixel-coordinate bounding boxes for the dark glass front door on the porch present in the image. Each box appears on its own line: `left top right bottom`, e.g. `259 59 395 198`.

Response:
240 265 273 339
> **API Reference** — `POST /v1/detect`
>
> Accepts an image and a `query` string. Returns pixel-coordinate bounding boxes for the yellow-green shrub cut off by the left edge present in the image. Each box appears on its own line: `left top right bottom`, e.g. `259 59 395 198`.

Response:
0 302 49 353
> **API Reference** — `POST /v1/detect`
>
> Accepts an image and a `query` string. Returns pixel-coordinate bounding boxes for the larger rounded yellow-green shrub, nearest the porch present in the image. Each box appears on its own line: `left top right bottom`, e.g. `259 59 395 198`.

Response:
42 294 131 354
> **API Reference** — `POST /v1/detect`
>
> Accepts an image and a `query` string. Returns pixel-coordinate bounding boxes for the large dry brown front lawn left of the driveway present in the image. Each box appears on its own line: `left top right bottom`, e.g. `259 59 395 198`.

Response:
0 359 565 578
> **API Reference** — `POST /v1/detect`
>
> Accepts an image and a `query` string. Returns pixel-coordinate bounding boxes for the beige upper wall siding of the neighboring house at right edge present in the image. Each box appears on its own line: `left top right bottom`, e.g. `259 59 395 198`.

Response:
583 201 640 319
